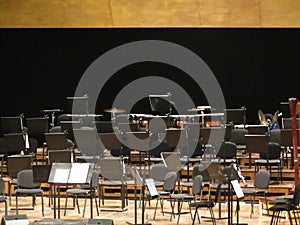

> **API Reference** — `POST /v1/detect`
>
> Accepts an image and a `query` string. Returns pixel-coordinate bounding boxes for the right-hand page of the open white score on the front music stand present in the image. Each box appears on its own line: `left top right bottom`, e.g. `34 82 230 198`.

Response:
68 163 89 184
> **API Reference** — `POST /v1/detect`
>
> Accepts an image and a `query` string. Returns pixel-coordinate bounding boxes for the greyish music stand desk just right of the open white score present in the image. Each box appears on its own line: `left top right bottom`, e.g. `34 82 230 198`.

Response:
99 158 124 180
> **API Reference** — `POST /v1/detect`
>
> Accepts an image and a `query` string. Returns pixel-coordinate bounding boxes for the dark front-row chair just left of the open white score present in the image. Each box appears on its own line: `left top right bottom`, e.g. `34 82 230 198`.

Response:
15 169 44 216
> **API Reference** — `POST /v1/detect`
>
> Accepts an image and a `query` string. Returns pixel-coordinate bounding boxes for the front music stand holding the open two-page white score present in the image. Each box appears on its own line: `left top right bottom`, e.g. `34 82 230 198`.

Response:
48 163 94 219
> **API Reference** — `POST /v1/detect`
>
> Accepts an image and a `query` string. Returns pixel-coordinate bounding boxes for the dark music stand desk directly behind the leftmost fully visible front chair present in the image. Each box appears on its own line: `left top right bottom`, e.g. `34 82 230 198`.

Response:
7 155 32 178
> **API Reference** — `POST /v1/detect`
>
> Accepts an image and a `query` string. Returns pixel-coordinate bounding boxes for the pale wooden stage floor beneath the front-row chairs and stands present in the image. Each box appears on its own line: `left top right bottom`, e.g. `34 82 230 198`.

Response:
0 193 296 225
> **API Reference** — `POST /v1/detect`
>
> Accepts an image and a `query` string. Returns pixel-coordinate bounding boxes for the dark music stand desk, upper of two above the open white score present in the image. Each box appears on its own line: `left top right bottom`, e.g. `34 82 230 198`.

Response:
45 132 68 150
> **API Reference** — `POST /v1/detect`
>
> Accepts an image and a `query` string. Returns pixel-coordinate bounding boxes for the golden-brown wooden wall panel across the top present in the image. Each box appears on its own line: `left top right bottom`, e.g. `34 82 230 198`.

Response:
0 0 300 27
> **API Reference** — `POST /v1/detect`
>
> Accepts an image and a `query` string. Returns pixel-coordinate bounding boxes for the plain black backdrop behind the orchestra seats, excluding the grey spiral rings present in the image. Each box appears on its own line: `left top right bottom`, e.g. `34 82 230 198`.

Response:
0 28 300 123
